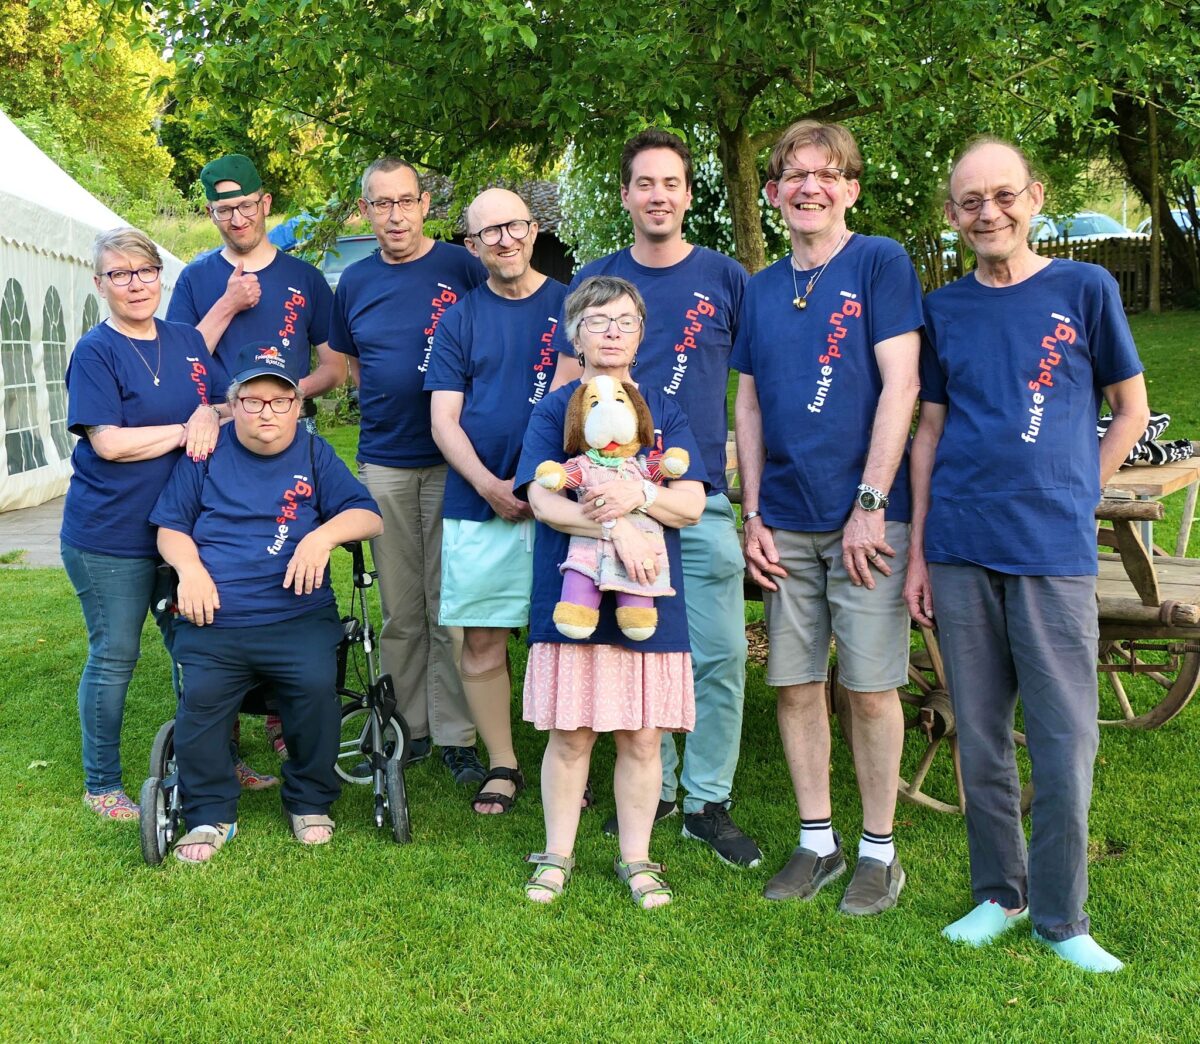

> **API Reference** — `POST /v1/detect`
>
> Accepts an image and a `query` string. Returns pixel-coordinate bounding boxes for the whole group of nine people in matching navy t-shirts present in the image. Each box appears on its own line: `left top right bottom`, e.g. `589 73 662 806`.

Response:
62 120 1148 971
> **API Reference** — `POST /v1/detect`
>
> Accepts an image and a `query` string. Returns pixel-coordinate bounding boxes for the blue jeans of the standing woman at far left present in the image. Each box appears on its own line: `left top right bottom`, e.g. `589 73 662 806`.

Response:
60 544 172 794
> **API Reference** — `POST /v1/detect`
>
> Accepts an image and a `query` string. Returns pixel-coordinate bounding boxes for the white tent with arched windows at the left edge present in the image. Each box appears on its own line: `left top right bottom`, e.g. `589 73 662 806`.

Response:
0 112 184 511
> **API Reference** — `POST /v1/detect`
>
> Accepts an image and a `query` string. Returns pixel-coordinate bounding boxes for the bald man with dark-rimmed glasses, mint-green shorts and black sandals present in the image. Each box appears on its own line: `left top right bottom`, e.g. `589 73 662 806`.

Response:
425 188 566 815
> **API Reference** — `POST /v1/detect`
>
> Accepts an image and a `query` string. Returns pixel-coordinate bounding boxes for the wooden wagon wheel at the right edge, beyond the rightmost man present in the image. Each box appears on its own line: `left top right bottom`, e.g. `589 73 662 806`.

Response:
1099 638 1200 728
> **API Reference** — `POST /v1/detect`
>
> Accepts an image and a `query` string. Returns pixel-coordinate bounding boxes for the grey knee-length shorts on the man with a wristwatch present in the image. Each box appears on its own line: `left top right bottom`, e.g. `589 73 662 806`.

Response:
763 522 908 692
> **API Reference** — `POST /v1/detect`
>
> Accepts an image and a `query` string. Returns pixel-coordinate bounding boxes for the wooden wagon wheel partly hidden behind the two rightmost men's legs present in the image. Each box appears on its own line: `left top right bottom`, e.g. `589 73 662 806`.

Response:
829 628 1033 815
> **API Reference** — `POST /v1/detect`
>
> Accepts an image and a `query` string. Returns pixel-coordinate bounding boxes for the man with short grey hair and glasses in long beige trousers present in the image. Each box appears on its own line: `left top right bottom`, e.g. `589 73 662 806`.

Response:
329 156 487 784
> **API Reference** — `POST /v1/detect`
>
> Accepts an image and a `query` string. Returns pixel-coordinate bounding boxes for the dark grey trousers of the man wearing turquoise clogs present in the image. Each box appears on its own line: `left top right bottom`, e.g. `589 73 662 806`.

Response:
929 563 1099 942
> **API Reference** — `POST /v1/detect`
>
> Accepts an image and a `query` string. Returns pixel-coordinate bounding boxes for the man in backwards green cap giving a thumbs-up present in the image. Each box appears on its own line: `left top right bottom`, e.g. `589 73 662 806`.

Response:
167 154 346 417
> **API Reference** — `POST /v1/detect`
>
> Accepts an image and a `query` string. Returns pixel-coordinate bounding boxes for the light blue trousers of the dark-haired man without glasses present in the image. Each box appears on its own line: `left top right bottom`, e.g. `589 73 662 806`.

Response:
659 494 746 814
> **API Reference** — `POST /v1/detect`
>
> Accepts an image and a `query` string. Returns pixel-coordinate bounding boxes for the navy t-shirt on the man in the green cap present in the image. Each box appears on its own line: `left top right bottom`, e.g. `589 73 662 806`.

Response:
167 251 334 401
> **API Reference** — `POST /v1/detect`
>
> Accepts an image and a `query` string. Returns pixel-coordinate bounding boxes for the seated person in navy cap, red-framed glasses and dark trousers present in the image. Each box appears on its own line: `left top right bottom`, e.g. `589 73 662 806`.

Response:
150 343 383 863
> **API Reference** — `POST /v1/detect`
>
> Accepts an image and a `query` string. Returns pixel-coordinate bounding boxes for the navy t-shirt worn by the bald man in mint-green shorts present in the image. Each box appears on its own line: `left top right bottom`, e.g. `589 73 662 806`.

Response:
425 280 566 522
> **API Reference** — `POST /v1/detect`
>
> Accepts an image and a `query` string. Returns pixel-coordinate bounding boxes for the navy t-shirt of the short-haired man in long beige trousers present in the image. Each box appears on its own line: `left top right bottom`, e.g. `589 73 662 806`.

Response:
329 242 487 468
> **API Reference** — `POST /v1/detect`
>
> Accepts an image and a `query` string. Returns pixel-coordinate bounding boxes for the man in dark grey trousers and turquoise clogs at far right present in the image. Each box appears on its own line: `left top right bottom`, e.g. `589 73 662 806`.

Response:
905 137 1150 972
